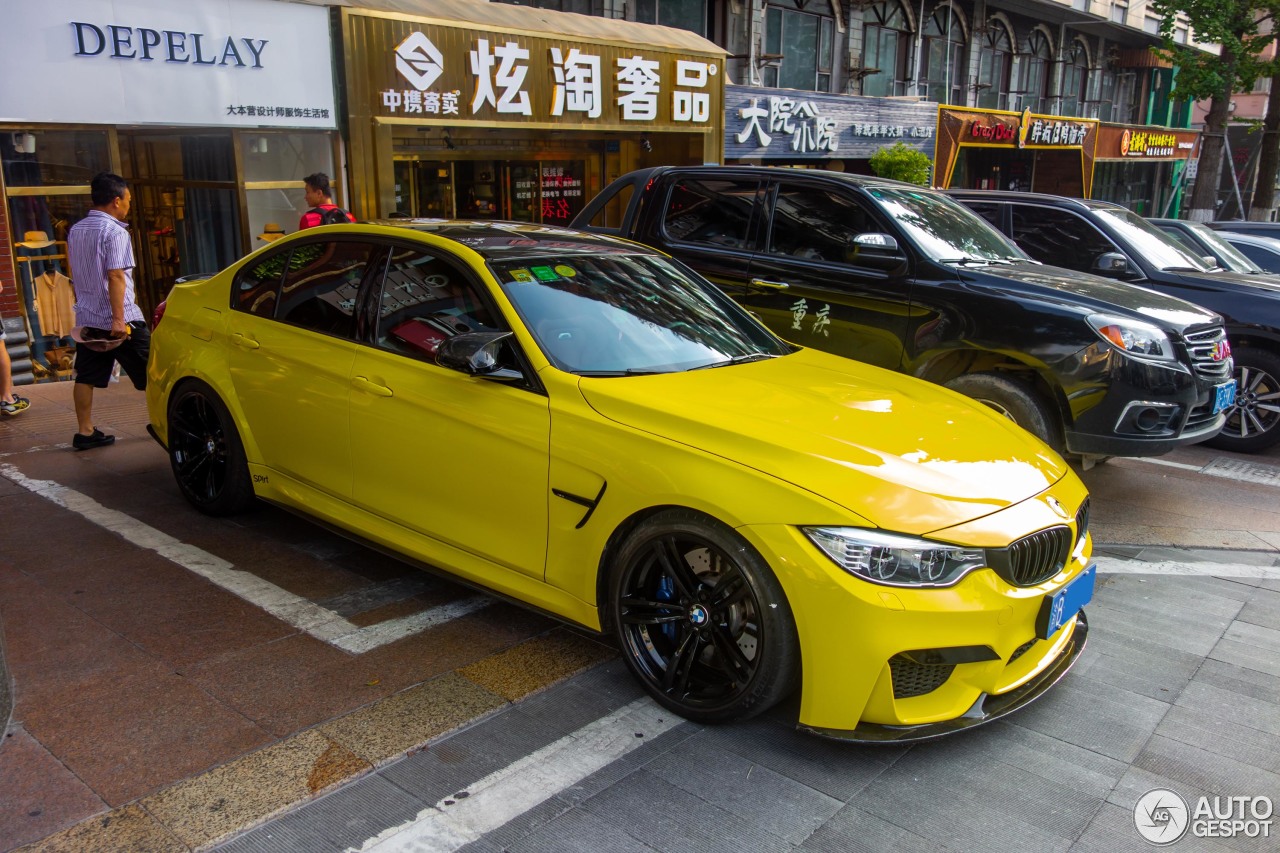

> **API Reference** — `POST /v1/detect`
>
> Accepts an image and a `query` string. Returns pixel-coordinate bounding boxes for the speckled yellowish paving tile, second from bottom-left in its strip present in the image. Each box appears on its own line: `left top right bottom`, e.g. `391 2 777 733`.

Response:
140 730 370 847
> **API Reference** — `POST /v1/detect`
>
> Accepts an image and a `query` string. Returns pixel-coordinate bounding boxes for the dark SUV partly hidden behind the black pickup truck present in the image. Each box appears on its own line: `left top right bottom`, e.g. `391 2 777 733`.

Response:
948 190 1280 453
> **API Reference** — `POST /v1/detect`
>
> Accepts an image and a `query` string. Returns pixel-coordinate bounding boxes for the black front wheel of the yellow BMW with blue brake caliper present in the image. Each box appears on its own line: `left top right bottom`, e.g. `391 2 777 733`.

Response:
609 510 799 722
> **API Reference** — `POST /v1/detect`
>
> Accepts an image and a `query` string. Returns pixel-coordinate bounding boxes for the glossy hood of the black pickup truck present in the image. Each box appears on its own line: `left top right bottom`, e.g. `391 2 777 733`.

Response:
959 263 1222 332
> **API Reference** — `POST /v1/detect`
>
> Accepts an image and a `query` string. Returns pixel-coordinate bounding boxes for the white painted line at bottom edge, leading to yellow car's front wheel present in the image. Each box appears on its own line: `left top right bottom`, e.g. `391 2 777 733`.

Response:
348 698 684 853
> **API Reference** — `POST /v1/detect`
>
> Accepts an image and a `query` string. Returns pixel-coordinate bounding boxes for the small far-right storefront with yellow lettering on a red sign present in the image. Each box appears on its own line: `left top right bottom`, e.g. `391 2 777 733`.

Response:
1093 124 1199 216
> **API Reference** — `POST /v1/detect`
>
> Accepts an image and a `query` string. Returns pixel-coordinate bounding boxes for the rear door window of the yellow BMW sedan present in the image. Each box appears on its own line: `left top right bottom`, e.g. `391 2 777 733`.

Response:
275 240 379 337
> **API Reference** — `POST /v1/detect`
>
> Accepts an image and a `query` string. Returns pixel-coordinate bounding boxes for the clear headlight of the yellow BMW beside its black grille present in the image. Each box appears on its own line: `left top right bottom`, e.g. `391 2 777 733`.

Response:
801 528 987 587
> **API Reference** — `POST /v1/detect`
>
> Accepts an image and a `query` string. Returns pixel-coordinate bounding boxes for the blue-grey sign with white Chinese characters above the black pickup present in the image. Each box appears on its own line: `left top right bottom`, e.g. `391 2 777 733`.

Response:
724 86 937 174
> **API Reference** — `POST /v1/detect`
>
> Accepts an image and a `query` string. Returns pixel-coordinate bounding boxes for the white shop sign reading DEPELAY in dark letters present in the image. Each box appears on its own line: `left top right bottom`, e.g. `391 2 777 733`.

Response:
0 0 337 129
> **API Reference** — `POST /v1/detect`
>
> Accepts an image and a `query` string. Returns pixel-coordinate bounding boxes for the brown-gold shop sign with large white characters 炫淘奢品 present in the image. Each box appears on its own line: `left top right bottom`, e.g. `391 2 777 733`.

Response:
348 20 723 129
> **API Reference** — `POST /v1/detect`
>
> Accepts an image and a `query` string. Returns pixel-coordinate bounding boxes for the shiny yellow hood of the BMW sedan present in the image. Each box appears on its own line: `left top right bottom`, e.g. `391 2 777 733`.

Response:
579 350 1068 534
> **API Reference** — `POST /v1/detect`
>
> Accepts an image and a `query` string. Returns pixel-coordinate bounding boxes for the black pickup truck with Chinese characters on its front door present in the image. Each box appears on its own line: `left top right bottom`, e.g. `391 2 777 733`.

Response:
573 167 1234 457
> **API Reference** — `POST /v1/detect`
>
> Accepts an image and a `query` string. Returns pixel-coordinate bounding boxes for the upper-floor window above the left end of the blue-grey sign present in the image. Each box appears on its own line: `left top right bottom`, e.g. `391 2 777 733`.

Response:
762 0 835 92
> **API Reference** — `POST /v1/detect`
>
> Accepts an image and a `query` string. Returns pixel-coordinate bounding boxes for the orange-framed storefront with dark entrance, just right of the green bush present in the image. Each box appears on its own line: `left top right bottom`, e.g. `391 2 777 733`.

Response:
933 106 1098 199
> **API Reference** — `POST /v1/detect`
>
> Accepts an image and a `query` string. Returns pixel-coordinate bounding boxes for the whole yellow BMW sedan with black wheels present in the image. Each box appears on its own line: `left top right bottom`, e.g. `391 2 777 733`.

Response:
147 220 1096 742
